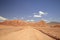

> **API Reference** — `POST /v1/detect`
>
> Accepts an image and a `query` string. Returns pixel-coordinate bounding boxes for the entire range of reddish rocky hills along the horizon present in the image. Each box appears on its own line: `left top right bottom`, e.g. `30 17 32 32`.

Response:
0 20 48 27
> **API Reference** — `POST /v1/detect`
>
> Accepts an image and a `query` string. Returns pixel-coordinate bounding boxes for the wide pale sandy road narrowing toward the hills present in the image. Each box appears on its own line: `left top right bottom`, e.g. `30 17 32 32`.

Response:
0 27 55 40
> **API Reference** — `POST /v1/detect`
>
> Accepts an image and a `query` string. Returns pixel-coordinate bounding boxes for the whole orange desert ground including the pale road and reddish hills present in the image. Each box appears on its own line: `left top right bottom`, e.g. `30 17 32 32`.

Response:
0 20 60 40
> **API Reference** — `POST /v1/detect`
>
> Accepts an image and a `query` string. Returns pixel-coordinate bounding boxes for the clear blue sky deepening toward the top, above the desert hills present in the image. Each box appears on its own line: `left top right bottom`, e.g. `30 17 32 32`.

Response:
0 0 60 22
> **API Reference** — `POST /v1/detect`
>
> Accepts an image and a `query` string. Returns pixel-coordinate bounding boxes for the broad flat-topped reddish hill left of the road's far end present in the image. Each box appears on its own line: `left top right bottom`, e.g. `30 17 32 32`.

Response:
0 20 27 26
